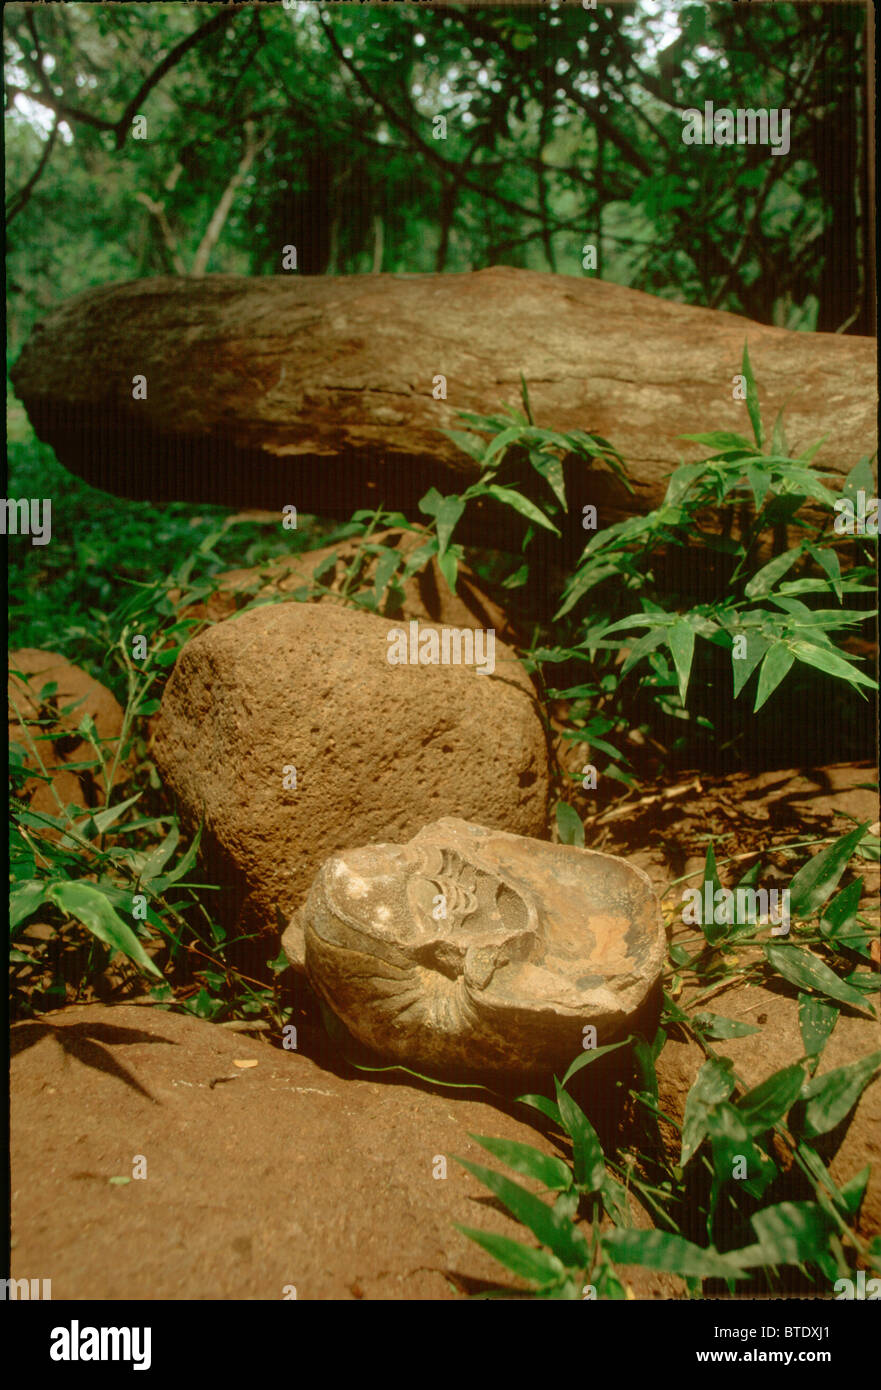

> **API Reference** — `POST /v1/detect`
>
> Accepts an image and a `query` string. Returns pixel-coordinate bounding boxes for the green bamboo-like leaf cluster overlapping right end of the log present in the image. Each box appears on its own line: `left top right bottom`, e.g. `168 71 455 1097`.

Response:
556 346 878 728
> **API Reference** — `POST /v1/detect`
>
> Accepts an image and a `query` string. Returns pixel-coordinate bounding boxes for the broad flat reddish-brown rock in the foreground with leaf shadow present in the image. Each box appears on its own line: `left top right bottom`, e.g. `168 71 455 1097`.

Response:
10 1005 682 1302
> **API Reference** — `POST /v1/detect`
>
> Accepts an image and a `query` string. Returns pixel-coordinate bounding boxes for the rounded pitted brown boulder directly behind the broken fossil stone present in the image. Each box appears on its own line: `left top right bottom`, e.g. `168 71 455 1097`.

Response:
154 602 549 930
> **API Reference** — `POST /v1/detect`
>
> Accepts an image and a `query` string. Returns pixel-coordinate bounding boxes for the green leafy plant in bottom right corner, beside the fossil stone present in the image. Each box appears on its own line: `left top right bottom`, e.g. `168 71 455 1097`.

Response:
457 826 881 1300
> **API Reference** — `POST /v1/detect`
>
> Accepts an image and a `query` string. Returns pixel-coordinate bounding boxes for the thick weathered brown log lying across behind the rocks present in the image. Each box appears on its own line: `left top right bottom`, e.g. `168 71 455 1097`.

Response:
11 267 877 545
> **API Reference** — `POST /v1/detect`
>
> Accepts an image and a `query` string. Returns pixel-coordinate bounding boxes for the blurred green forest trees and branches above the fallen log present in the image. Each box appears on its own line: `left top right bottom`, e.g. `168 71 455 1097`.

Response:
4 3 874 348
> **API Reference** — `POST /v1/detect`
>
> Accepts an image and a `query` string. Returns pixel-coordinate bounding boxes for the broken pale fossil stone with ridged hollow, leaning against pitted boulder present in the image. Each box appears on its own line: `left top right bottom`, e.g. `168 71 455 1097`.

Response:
283 819 664 1072
